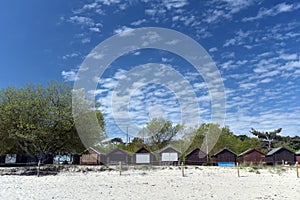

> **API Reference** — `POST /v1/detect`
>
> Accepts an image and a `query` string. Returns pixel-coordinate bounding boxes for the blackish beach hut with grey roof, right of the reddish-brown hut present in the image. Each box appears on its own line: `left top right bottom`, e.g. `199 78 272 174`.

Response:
266 147 295 165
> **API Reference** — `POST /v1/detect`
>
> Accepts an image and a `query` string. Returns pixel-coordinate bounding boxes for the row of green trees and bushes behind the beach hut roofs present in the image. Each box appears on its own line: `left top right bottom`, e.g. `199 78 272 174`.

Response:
104 118 300 155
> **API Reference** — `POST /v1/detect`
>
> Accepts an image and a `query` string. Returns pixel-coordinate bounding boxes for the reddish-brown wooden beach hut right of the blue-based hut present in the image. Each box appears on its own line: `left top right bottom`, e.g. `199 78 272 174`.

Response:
237 148 266 165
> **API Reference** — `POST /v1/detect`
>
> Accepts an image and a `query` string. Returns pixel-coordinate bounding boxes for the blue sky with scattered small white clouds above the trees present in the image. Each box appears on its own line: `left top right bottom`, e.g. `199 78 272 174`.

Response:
0 0 300 141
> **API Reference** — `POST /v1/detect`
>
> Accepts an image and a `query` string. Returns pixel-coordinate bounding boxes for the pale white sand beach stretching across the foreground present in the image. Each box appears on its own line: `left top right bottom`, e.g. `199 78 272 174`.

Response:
0 167 300 200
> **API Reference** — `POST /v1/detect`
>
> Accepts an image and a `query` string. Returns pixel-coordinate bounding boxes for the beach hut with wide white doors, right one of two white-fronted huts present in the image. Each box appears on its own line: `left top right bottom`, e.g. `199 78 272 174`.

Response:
158 145 181 165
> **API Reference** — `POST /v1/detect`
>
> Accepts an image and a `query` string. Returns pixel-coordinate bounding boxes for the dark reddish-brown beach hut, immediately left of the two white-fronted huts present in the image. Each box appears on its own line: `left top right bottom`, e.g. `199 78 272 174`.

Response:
106 148 131 165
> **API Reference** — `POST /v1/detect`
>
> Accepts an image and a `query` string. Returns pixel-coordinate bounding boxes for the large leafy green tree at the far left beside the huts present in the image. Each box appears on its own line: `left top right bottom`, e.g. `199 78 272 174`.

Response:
0 82 103 162
